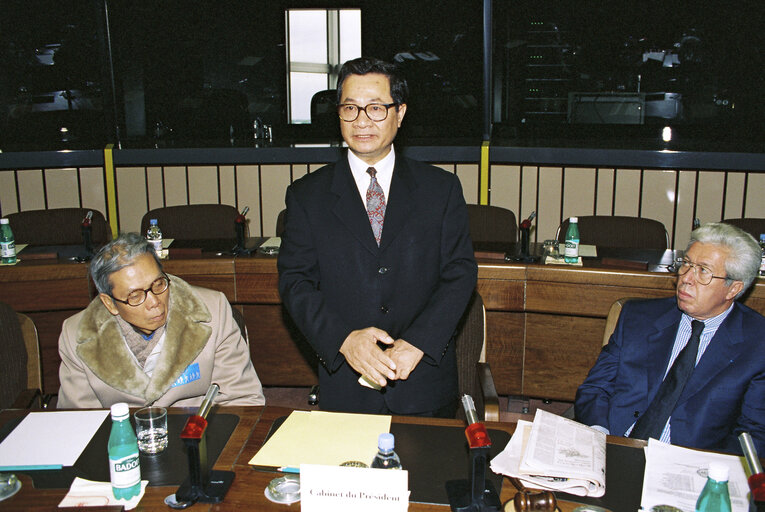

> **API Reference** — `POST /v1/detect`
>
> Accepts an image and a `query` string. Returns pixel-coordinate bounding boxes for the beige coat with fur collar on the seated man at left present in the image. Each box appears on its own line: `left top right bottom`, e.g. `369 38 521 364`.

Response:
58 276 265 408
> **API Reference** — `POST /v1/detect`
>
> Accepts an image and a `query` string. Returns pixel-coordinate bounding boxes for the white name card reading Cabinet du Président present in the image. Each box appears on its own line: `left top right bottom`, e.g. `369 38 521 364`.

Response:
300 464 409 512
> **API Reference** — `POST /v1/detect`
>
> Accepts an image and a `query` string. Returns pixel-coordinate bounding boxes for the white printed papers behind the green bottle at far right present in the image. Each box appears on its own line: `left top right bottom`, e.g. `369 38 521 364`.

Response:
640 439 749 512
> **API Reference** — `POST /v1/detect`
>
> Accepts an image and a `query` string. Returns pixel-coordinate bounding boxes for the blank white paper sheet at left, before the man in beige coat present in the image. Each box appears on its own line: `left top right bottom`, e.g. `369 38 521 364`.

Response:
0 410 109 471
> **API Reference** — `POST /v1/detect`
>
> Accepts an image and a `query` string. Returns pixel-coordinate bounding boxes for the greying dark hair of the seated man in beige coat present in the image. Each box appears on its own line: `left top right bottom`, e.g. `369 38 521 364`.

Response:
90 233 162 297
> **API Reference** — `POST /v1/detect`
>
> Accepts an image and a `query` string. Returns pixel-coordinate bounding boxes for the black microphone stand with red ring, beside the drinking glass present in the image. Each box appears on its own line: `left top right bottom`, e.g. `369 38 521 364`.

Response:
175 383 234 503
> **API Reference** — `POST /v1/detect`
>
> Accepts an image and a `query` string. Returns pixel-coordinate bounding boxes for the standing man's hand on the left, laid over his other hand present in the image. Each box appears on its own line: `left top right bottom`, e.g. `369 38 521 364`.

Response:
340 327 396 387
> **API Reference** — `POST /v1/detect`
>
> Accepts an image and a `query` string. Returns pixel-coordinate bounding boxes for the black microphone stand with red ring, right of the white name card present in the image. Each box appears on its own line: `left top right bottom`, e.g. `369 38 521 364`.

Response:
446 395 502 512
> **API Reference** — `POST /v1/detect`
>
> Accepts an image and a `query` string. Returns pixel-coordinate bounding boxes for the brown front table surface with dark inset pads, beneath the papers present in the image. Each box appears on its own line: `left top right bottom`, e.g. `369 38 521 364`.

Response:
0 405 645 512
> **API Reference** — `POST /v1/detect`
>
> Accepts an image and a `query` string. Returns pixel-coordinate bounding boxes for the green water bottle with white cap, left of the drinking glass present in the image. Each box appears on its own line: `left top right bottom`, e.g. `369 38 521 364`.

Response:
109 402 141 500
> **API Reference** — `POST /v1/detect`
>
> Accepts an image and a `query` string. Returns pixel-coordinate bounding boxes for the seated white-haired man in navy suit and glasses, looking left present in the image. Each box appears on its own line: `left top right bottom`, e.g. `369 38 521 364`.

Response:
575 224 765 454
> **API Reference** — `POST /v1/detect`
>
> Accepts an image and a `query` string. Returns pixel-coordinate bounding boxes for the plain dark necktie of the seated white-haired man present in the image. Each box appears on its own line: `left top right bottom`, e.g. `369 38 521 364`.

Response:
630 320 704 439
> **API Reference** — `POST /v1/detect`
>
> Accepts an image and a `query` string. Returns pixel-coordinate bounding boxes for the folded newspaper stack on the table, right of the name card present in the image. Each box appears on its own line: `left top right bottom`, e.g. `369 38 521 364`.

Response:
491 410 606 498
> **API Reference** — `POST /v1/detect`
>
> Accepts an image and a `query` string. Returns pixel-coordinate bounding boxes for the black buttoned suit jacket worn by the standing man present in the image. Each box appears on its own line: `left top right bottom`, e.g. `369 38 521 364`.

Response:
278 155 477 414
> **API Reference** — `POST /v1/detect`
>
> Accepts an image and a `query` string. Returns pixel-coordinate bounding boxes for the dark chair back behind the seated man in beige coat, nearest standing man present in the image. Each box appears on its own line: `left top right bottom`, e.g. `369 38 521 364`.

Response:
141 204 242 240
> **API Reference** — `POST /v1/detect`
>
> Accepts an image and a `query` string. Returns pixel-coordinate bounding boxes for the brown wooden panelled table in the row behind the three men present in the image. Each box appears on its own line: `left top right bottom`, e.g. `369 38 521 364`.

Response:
0 239 765 401
